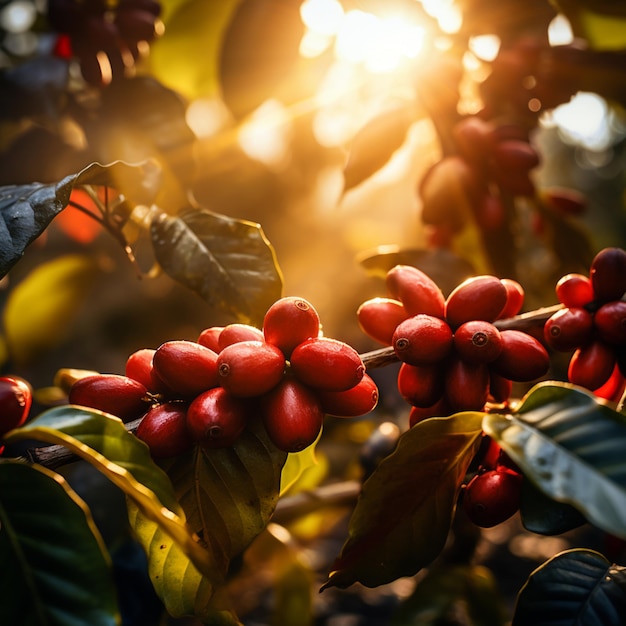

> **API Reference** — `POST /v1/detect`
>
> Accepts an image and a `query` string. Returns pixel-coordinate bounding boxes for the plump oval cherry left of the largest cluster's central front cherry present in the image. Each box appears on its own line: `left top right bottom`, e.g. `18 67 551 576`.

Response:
152 339 219 399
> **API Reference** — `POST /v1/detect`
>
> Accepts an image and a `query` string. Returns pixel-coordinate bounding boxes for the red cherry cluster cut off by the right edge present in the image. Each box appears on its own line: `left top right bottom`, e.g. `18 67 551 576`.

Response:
544 248 626 402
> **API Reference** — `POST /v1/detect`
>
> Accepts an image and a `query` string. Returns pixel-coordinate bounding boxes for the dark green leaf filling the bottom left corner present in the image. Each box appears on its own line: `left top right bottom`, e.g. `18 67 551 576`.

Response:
0 460 119 626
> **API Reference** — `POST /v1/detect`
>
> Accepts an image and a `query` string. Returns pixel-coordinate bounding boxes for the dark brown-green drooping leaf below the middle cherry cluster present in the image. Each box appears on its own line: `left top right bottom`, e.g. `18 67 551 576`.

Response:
322 412 484 589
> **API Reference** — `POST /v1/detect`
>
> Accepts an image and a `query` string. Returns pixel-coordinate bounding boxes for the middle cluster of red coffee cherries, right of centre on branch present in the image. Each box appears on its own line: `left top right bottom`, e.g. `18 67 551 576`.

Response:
357 265 549 425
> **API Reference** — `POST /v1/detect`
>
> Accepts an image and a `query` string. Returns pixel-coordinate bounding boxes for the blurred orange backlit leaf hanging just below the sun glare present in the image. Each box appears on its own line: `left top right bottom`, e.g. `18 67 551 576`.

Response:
343 103 417 192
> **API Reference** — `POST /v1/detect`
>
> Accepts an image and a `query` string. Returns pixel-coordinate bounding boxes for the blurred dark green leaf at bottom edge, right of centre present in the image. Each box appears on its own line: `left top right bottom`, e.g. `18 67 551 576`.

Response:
390 565 505 626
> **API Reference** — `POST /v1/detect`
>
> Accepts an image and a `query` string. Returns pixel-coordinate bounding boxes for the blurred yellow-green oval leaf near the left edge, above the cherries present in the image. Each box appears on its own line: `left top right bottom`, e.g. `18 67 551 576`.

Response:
2 254 98 365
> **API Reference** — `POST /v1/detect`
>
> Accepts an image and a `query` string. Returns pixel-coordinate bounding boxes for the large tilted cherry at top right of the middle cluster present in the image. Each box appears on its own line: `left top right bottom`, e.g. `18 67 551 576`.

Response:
445 275 508 329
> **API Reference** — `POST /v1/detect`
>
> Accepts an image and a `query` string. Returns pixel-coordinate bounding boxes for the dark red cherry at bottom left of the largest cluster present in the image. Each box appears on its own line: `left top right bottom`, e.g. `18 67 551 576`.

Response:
135 402 193 459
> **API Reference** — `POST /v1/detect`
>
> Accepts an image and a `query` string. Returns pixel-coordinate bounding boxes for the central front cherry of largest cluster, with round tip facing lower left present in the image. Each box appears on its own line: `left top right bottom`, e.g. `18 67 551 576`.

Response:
217 341 285 398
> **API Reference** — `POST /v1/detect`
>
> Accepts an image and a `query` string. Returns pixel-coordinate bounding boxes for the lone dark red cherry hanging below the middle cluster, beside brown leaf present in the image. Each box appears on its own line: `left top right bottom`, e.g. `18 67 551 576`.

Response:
463 469 523 528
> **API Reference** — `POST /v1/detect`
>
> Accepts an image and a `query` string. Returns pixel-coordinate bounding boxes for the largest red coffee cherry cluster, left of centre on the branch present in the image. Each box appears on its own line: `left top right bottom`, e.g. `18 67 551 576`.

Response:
68 297 378 458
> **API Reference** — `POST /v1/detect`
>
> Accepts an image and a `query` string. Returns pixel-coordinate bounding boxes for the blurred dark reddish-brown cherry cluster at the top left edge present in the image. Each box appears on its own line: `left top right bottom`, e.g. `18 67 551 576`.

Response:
48 0 163 86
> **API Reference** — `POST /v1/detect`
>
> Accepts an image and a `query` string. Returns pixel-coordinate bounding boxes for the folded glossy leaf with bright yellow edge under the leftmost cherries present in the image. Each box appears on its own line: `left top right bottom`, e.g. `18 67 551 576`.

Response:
5 405 215 573
